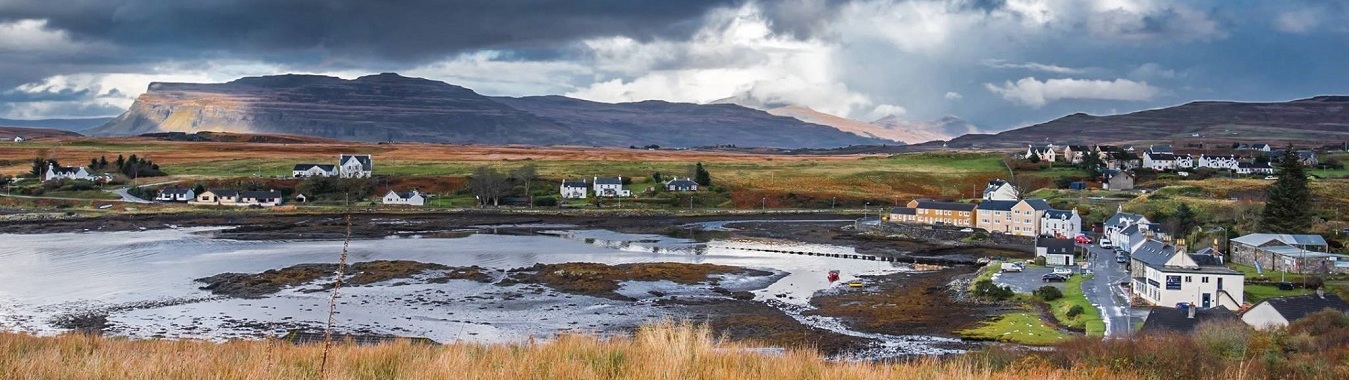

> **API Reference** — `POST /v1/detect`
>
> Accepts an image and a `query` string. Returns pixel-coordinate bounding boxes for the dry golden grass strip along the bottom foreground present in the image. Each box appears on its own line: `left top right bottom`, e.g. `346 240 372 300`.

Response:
0 323 1139 380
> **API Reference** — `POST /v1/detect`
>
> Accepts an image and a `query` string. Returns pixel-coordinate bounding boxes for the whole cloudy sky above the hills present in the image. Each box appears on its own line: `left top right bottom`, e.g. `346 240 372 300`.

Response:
0 0 1349 131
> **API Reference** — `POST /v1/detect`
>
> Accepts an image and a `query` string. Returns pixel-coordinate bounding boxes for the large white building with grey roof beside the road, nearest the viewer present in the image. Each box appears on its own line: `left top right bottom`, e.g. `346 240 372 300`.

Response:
1129 240 1245 310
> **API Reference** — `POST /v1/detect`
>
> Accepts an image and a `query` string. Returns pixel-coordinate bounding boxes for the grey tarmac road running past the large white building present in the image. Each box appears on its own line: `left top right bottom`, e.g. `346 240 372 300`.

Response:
1079 245 1148 337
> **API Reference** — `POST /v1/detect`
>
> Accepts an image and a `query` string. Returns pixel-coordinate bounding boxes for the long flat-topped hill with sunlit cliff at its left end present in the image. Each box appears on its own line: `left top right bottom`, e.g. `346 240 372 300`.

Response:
89 74 877 148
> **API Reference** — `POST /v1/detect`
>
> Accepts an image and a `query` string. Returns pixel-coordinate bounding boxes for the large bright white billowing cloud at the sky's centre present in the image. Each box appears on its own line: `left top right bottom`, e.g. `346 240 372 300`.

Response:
567 4 876 116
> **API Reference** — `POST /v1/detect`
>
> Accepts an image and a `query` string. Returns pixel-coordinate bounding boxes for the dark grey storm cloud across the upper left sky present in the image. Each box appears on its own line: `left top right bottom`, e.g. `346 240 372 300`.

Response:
0 0 742 62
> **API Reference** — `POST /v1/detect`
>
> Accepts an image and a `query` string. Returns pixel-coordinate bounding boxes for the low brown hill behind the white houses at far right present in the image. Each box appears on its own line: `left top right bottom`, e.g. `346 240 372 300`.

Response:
929 96 1349 148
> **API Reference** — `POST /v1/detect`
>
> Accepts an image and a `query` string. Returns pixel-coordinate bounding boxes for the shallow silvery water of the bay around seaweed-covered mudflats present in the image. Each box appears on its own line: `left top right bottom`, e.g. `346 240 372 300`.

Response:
0 229 960 355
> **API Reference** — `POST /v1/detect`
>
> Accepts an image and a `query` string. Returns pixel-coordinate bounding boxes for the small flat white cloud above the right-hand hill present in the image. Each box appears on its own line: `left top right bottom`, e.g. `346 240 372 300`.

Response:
983 77 1159 108
